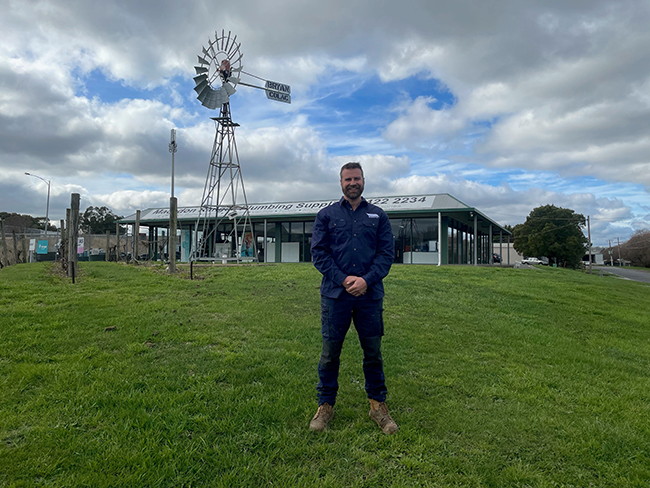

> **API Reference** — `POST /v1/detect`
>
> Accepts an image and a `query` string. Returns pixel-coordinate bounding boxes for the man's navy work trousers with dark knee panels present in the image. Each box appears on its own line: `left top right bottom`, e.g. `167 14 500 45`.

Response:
316 296 387 406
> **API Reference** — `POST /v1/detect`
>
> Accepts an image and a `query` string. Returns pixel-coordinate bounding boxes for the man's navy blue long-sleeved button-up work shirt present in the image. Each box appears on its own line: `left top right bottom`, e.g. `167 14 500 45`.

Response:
311 197 395 300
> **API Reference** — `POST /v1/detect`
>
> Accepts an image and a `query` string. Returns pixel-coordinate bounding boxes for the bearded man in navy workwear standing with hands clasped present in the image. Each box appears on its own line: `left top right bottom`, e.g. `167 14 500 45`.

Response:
309 163 398 434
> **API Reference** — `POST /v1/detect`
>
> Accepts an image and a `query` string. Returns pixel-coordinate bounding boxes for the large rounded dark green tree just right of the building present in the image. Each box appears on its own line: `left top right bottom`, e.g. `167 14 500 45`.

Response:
513 205 587 268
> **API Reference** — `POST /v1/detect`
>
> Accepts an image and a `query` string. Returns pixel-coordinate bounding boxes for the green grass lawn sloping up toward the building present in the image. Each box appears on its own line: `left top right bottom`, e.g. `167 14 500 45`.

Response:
0 262 650 487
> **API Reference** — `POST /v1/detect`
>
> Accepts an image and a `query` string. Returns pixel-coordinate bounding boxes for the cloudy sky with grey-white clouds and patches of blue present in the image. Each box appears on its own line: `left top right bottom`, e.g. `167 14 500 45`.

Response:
0 0 650 245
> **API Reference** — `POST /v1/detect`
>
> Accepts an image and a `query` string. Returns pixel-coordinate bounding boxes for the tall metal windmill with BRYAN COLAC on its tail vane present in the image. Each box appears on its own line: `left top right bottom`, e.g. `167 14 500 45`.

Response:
191 30 291 263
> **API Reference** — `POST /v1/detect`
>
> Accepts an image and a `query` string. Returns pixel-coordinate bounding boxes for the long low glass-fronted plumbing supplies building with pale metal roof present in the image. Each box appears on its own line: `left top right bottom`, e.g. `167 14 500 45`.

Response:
121 193 512 265
